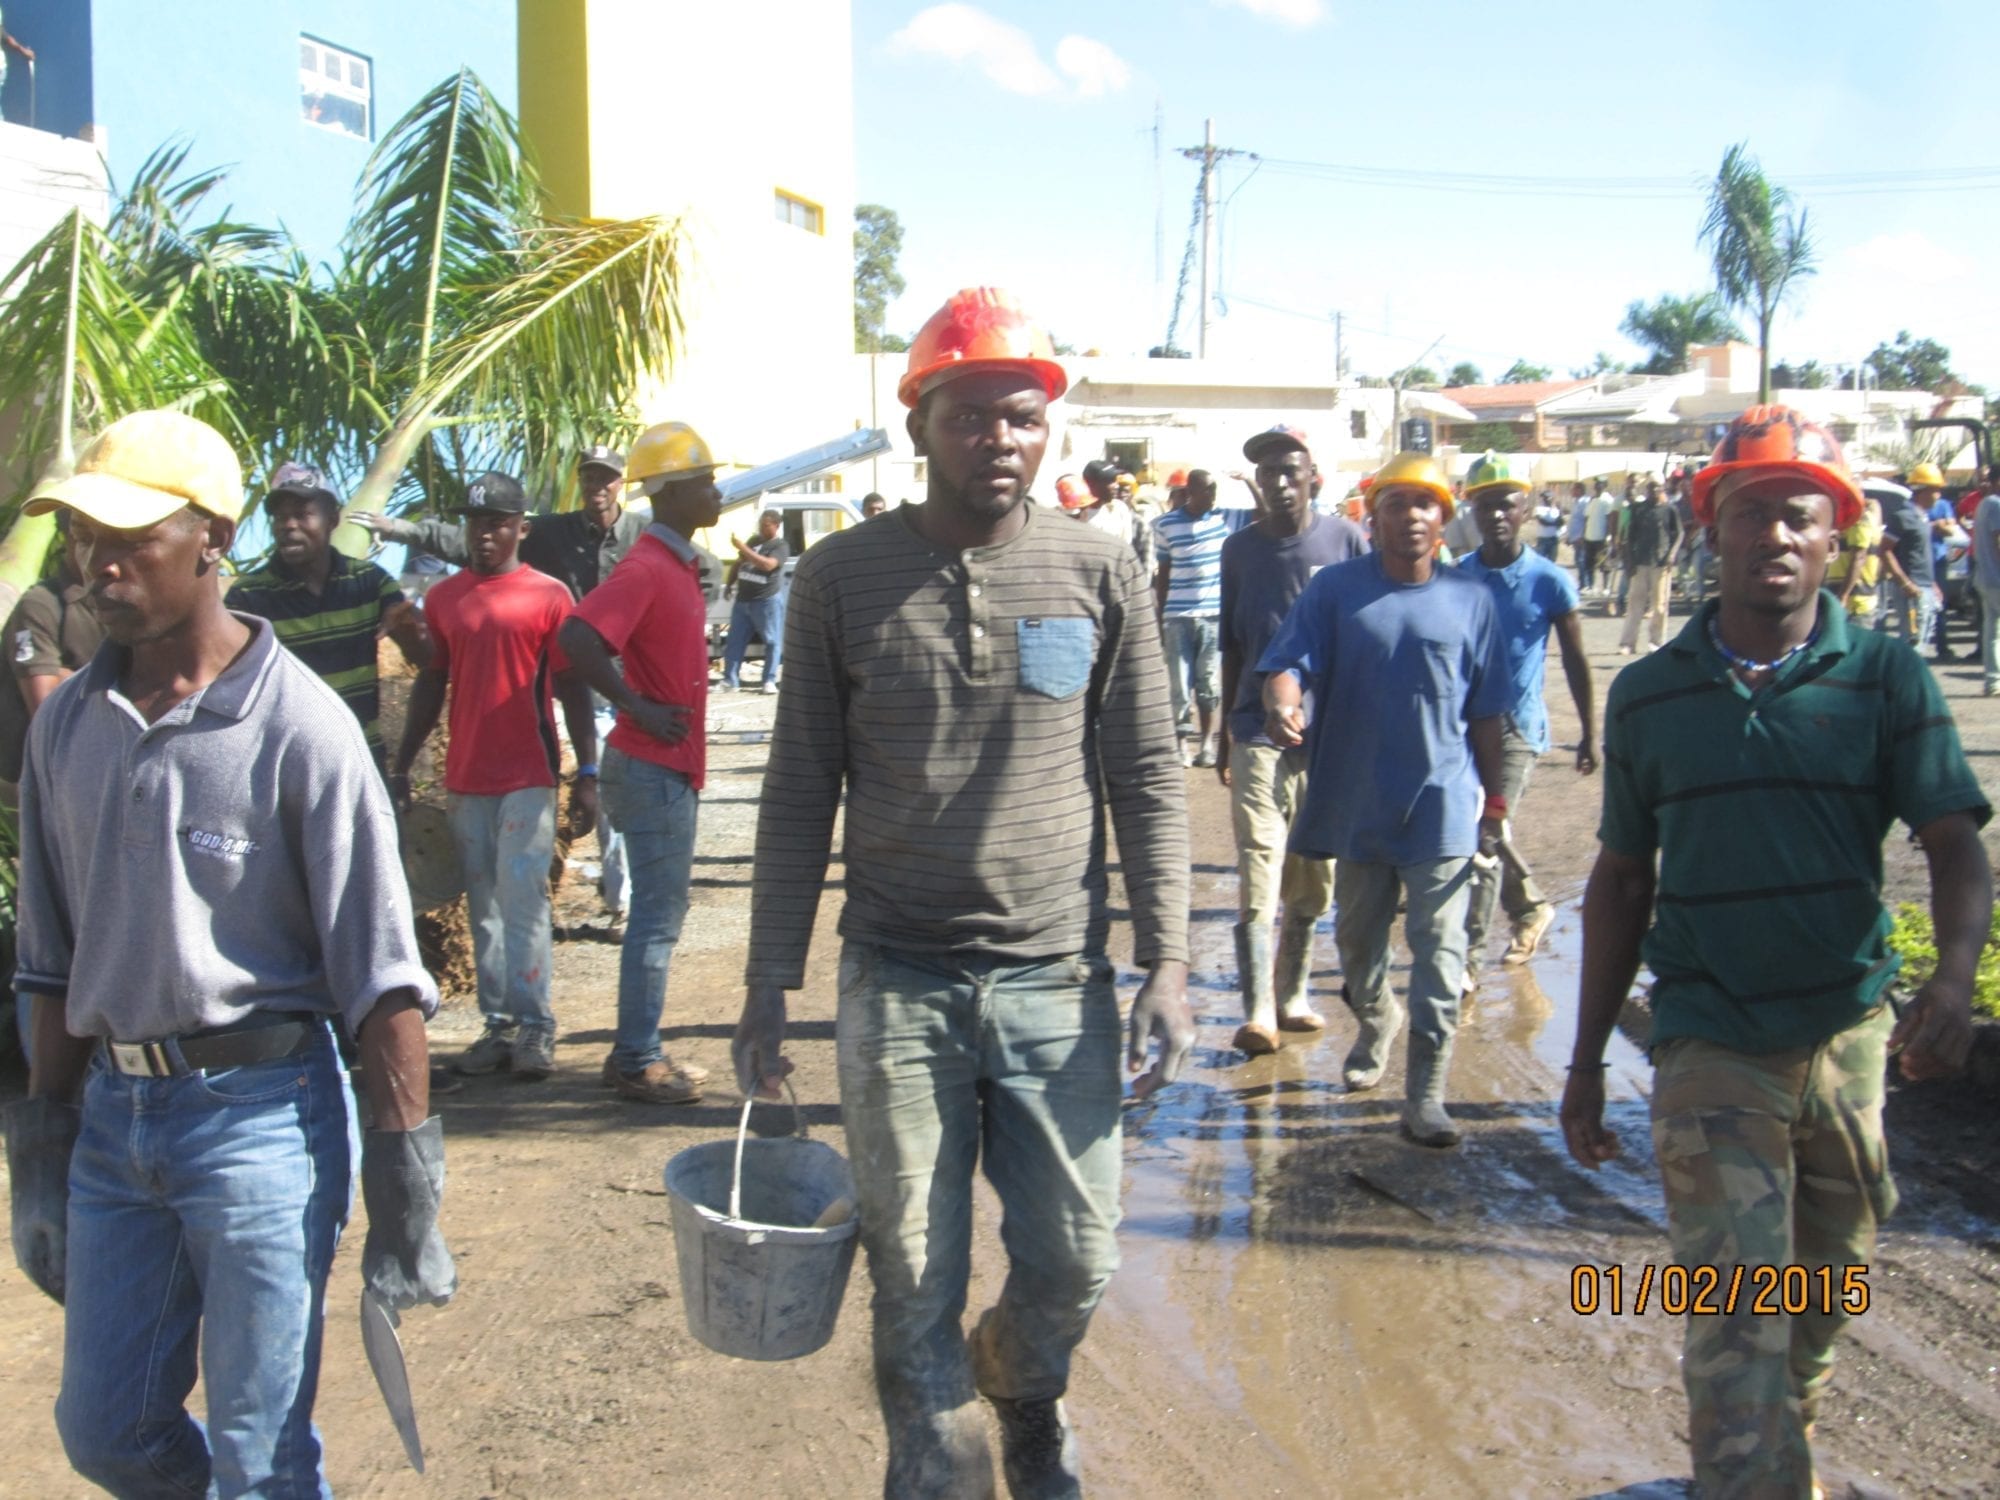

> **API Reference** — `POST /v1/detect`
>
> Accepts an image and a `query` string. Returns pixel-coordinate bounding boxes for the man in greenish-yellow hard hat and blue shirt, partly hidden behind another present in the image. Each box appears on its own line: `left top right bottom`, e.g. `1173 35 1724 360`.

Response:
1458 454 1598 980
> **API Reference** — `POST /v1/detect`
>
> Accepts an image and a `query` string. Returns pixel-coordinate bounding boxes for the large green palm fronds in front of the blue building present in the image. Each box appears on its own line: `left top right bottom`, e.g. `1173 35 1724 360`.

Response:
0 72 686 600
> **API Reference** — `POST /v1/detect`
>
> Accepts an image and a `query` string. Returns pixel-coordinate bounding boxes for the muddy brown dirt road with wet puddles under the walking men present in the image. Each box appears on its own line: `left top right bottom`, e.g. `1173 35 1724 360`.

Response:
0 604 2000 1500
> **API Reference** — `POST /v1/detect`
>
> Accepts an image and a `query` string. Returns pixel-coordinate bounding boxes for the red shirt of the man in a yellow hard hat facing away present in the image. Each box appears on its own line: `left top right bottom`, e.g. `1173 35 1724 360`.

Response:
576 528 708 792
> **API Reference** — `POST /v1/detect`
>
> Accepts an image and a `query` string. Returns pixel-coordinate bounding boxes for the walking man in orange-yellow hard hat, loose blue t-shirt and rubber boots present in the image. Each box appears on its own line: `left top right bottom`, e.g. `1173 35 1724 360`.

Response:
1258 454 1514 1146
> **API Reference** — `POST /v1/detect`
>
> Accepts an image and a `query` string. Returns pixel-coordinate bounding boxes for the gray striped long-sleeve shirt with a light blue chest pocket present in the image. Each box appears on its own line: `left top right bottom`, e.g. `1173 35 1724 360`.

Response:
746 506 1188 988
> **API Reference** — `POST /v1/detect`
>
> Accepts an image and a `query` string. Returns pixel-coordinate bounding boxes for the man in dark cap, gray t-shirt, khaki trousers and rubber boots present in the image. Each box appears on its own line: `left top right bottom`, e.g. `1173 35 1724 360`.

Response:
1216 426 1368 1056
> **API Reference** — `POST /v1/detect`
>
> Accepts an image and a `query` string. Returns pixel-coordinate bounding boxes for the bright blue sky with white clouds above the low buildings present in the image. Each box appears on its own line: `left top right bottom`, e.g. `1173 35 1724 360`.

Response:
854 0 2000 388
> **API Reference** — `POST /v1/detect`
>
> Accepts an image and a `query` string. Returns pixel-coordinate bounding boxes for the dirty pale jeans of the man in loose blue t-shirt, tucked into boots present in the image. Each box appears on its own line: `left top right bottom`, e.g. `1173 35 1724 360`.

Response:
1334 856 1472 1048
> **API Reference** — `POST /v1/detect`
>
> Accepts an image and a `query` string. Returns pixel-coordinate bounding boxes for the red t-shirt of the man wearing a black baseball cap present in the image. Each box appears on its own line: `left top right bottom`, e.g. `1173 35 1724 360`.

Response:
424 566 570 796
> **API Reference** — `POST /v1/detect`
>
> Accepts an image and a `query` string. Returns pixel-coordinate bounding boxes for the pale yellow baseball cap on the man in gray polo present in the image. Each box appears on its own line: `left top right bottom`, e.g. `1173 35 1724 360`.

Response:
22 412 244 532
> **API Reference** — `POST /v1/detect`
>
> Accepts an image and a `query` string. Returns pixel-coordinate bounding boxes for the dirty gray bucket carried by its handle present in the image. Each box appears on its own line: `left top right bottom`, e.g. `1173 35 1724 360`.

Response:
666 1094 860 1360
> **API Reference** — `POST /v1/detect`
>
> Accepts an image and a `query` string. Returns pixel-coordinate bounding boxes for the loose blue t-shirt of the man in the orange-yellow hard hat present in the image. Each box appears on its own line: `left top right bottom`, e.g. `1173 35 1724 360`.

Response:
1258 554 1514 864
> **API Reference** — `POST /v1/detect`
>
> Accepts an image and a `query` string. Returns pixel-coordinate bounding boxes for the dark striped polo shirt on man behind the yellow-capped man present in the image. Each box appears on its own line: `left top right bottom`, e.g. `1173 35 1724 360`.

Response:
230 552 402 758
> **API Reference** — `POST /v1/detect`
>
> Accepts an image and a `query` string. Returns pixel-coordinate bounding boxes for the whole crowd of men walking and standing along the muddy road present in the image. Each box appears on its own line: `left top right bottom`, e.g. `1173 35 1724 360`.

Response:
8 288 2000 1496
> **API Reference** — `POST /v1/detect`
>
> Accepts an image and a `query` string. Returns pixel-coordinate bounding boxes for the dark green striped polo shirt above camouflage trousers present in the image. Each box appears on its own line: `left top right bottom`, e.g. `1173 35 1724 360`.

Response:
1598 592 1990 1052
